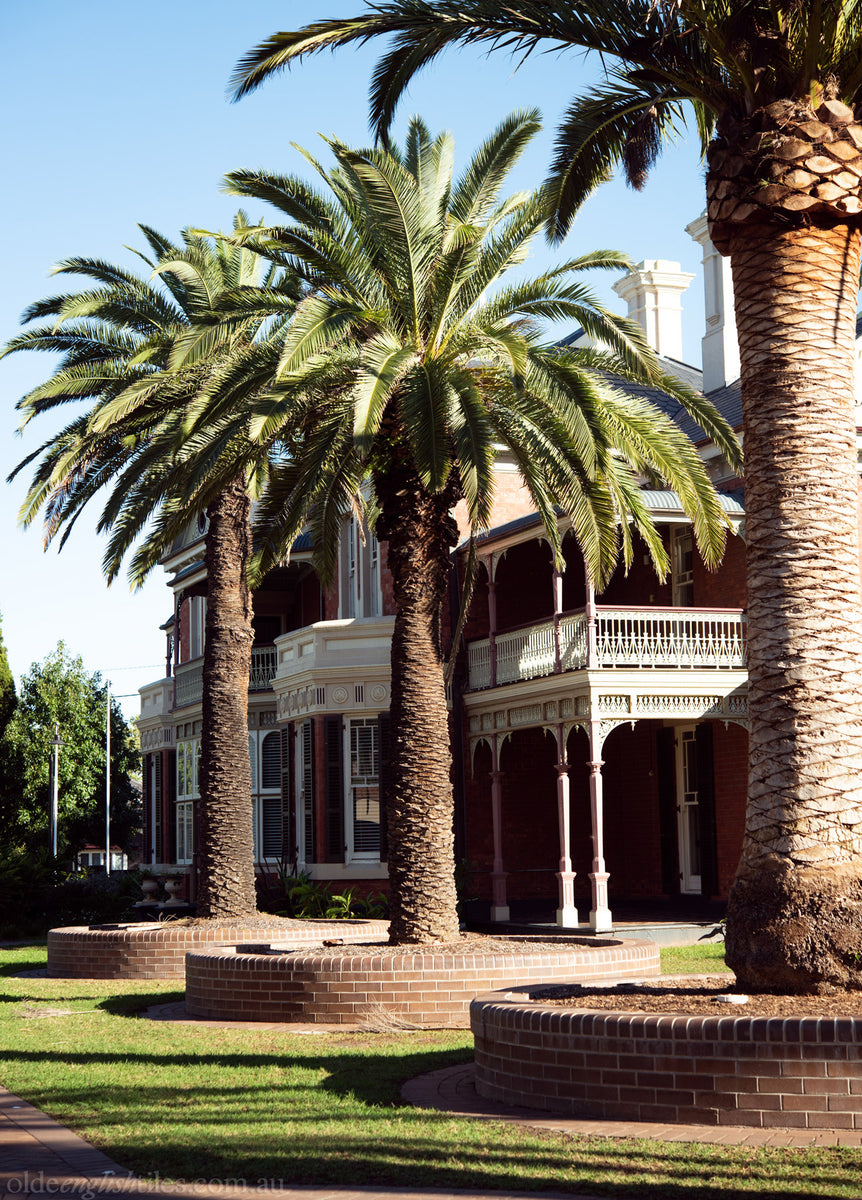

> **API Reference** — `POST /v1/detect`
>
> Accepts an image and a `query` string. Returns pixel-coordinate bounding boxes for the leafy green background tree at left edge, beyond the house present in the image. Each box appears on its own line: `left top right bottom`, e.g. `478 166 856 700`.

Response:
0 642 140 859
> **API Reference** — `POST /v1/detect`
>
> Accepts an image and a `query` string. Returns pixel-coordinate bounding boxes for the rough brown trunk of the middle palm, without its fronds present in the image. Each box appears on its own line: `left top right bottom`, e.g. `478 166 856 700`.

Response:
377 470 459 946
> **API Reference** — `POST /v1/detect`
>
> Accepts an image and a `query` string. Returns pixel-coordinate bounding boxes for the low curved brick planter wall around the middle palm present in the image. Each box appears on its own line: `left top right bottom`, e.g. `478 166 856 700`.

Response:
180 938 659 1028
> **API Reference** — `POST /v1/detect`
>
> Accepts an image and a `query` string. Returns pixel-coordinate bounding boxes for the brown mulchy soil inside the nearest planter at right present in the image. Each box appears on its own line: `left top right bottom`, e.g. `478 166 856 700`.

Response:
529 974 862 1018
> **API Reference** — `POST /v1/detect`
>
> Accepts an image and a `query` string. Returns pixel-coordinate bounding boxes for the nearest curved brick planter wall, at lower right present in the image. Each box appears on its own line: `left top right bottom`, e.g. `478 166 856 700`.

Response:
471 988 862 1129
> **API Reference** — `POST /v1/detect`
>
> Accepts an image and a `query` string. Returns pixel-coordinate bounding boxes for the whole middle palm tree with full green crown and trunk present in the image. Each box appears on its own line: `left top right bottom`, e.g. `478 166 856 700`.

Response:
217 113 738 943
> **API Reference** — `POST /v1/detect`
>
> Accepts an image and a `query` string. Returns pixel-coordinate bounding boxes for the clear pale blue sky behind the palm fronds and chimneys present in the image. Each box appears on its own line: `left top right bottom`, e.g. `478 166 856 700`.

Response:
0 0 704 715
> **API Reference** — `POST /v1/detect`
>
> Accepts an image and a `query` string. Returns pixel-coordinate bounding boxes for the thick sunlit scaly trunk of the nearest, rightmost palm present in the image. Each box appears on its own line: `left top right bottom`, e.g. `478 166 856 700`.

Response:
728 224 862 992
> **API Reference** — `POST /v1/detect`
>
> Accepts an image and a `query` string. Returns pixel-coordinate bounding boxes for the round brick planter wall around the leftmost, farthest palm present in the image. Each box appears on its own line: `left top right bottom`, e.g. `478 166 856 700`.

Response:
48 920 388 979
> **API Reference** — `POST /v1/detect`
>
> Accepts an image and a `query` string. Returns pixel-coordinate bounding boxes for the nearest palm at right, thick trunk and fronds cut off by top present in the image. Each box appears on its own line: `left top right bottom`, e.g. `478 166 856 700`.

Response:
231 0 862 991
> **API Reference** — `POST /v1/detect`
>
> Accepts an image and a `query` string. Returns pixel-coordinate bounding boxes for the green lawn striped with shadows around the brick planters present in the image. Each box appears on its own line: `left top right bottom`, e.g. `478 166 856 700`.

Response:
0 946 862 1200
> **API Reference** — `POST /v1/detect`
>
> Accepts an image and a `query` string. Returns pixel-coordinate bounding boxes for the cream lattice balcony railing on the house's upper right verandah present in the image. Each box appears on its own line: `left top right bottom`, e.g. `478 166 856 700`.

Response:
468 606 746 691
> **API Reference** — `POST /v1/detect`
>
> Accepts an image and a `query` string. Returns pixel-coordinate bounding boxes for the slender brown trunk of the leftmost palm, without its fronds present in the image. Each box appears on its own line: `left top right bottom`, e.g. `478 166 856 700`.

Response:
198 479 257 918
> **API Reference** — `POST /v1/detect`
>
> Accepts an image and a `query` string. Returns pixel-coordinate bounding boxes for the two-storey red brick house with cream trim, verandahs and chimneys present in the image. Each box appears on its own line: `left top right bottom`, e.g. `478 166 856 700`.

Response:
140 218 777 930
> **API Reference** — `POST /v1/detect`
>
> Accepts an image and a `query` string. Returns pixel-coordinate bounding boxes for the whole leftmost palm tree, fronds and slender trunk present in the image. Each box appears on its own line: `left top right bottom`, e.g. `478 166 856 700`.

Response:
2 223 299 918
